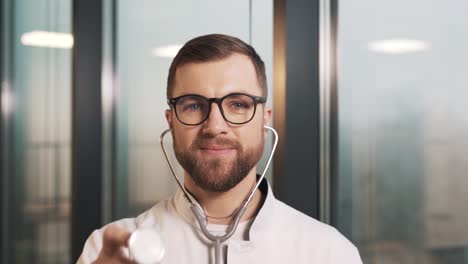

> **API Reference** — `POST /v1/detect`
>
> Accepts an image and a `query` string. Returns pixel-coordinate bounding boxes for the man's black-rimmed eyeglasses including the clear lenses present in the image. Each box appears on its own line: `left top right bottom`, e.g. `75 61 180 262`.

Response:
167 93 266 126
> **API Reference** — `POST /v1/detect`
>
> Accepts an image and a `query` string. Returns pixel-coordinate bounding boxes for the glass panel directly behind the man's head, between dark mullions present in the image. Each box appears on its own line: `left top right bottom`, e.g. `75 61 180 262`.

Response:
114 0 273 218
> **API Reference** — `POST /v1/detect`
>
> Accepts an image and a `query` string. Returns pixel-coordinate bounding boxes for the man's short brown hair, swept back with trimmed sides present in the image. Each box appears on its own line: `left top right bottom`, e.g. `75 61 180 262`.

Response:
166 34 268 98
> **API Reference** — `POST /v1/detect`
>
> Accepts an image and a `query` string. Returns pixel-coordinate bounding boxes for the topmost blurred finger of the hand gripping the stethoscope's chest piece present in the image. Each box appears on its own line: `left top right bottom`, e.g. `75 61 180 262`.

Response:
102 224 131 256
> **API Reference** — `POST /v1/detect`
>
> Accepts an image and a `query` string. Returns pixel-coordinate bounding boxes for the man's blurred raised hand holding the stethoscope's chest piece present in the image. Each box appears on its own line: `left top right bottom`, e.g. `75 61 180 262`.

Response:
93 224 136 264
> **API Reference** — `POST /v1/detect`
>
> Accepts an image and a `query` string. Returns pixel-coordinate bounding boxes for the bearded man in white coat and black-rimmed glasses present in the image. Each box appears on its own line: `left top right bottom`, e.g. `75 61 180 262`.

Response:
78 34 361 264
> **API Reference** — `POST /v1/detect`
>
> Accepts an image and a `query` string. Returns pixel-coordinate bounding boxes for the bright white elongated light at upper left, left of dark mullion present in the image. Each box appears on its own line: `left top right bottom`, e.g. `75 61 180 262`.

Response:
21 31 73 49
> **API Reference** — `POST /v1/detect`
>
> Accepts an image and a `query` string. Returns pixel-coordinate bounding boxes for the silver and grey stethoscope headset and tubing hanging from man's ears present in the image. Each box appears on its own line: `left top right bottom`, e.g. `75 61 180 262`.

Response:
148 126 278 264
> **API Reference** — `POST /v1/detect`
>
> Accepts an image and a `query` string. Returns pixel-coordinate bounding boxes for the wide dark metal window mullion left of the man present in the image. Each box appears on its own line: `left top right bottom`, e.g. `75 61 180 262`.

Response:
71 0 103 261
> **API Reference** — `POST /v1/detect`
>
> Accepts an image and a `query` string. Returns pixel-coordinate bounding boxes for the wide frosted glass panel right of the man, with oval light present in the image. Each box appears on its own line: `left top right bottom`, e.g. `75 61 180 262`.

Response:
335 0 468 264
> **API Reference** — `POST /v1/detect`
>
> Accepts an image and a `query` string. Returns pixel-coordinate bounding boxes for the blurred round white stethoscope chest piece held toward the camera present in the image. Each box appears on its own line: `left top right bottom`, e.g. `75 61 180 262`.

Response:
128 228 166 264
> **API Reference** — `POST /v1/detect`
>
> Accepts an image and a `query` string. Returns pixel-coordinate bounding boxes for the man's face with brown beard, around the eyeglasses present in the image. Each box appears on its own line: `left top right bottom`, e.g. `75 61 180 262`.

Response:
166 54 271 192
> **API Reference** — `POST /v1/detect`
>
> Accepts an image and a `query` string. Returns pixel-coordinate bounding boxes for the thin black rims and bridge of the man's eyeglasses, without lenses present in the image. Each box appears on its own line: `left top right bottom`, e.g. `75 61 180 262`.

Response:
167 93 267 126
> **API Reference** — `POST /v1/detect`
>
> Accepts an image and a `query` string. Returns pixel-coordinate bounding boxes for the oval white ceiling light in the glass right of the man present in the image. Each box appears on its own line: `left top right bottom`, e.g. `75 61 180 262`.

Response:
368 39 430 54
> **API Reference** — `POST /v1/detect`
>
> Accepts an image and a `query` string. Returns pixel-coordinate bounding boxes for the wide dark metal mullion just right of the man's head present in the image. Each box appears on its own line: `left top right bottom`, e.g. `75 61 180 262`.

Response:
274 0 320 218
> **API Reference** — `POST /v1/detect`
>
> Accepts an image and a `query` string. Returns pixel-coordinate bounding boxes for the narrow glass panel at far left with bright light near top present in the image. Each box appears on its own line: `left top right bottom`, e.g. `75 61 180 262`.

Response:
2 0 73 263
